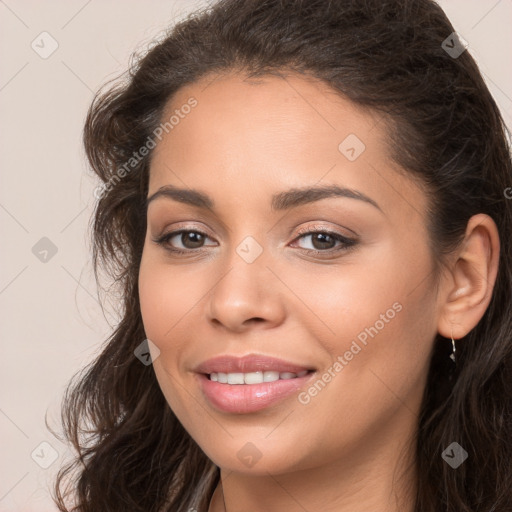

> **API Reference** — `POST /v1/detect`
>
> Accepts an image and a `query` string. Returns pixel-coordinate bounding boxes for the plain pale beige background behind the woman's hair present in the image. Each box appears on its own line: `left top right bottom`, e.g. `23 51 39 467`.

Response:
0 0 512 512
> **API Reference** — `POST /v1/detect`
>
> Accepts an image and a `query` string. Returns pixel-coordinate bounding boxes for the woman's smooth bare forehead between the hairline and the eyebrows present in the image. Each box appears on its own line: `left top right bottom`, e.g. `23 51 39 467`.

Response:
148 73 428 223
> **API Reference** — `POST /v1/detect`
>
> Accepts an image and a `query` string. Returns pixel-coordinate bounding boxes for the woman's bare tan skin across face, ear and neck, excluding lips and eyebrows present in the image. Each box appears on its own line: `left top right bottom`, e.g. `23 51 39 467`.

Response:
139 73 499 512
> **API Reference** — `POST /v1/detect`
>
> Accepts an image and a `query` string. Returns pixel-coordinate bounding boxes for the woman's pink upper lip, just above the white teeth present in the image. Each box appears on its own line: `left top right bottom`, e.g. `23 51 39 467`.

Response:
195 354 314 374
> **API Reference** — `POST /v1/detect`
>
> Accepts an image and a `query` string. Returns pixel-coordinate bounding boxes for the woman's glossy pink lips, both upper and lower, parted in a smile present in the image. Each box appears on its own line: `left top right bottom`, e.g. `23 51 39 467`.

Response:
195 355 314 414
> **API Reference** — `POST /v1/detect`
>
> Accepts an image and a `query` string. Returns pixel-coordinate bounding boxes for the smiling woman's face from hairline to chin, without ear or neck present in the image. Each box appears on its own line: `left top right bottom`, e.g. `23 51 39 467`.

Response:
139 74 437 474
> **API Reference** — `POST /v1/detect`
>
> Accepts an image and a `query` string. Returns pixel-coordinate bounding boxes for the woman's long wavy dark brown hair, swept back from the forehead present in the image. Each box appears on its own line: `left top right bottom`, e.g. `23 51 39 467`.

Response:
55 0 512 512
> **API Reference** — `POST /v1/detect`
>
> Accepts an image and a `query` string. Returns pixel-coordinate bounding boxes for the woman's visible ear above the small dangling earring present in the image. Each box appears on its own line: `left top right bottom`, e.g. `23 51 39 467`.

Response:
437 213 500 339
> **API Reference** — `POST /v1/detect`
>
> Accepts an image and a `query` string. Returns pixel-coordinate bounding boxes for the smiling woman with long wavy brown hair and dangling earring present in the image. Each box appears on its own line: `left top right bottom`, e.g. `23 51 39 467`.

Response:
52 0 512 512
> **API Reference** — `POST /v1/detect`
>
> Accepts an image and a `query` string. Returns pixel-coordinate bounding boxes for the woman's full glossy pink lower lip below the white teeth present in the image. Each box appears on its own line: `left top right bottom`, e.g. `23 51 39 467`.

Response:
197 372 314 414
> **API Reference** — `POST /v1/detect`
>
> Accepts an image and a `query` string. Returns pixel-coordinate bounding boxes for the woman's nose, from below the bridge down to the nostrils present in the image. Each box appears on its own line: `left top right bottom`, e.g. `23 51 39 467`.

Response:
207 247 285 333
